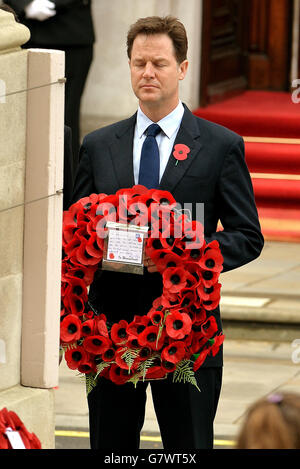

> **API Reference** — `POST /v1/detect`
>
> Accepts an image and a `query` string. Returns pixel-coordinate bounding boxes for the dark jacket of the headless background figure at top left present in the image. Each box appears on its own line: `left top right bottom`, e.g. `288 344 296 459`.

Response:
5 0 95 48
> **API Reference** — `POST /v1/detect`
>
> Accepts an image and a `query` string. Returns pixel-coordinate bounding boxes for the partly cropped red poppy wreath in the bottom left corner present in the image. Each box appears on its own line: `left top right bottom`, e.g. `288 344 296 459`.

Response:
0 407 41 449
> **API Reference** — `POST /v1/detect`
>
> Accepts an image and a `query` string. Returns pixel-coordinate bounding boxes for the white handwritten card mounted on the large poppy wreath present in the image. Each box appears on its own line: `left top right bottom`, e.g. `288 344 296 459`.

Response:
107 229 144 264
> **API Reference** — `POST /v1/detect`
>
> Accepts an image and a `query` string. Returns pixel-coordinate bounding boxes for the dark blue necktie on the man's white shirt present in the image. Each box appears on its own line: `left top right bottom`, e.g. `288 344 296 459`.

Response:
139 124 161 189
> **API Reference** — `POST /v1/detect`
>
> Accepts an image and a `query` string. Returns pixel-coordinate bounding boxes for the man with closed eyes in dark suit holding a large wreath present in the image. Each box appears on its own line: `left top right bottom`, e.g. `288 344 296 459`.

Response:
73 17 263 451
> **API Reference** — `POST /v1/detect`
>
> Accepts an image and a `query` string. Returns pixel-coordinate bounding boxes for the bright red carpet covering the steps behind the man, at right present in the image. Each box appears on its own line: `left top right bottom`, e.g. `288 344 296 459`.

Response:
194 91 300 242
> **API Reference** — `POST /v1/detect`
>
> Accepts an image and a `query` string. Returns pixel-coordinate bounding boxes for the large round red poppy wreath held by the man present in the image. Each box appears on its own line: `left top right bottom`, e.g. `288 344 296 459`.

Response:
60 185 224 392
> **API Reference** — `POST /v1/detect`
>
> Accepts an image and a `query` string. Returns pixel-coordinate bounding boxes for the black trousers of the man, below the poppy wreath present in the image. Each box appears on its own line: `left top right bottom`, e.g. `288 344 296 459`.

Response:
88 367 222 450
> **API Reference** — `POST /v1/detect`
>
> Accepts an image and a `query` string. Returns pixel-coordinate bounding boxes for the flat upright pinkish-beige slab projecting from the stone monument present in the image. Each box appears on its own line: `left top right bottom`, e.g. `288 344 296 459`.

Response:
21 49 64 388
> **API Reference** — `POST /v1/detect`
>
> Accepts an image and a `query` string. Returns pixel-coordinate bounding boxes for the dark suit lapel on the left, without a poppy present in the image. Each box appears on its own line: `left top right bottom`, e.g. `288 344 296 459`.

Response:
110 114 136 189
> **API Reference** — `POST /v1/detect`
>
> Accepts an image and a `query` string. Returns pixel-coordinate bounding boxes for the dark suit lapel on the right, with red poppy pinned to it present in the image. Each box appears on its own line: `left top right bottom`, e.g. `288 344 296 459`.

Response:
159 106 203 192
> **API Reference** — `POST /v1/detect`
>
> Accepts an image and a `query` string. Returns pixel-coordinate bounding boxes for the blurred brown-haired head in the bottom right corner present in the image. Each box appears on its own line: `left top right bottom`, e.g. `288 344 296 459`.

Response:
237 393 300 449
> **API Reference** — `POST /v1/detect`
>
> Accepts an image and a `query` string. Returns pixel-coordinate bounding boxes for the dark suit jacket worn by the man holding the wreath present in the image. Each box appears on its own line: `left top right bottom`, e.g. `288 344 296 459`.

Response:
72 106 264 366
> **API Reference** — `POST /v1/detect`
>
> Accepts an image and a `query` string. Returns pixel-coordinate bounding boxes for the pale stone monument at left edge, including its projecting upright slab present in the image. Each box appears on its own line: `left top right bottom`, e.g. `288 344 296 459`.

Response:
0 10 64 449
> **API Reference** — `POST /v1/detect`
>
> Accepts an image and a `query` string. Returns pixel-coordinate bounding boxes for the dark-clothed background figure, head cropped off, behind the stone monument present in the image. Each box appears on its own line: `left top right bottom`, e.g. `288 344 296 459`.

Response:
5 0 95 175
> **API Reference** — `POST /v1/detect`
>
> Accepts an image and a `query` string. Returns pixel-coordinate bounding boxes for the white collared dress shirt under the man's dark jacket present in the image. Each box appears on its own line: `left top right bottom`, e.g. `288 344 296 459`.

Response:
133 101 184 184
